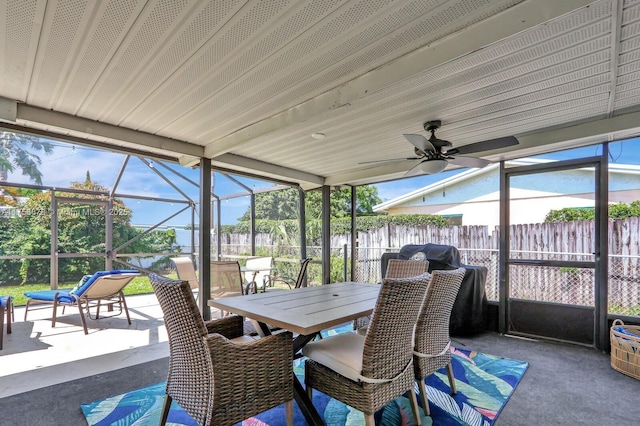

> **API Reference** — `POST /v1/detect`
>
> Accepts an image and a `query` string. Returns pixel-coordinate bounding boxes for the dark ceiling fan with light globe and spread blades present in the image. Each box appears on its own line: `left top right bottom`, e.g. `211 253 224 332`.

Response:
360 120 518 176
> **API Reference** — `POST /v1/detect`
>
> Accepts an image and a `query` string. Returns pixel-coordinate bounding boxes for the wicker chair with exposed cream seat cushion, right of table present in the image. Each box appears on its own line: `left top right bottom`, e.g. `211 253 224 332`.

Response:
303 274 429 425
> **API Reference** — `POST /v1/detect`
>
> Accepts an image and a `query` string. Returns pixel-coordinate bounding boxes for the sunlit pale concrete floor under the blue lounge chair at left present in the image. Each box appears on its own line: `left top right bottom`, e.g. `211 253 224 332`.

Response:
0 294 169 398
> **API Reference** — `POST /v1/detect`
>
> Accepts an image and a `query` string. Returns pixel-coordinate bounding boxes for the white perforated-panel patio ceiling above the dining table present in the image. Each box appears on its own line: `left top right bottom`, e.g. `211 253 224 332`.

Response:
0 0 640 188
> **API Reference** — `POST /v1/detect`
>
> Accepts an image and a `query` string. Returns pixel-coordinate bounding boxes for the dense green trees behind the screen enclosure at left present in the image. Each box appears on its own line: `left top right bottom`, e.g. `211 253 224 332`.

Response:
0 172 177 283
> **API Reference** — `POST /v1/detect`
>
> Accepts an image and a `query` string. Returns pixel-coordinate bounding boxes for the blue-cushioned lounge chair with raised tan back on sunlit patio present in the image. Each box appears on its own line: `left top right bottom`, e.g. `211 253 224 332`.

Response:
24 270 140 334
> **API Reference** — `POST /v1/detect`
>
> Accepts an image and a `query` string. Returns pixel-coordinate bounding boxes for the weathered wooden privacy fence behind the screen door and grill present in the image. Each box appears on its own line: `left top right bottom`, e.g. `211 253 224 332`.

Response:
223 217 640 315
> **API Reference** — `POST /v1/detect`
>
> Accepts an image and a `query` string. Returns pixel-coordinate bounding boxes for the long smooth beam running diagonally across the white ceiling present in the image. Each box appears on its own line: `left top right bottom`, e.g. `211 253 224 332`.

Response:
204 0 592 158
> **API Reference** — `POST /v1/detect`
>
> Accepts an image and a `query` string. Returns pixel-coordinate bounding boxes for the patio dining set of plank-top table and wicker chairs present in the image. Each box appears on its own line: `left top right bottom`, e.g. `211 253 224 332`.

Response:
149 259 465 425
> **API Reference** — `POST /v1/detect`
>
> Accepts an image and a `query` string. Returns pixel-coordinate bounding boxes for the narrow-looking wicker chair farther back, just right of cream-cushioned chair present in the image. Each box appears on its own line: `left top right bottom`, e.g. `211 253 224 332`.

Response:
413 268 465 415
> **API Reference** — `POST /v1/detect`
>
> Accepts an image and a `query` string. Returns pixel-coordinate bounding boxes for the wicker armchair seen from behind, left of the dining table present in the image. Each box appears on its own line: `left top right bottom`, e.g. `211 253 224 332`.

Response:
149 274 293 426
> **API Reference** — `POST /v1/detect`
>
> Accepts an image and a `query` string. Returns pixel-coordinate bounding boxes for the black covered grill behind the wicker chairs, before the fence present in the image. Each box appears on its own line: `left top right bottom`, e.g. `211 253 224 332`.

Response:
396 244 488 336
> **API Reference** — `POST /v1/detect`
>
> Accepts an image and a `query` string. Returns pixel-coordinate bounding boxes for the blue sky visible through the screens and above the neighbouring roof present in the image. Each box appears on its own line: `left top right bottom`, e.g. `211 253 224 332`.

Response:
9 135 640 233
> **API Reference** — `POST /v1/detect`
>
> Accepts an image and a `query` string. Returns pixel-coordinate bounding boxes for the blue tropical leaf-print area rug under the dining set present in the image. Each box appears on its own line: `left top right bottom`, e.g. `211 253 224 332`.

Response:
81 347 528 426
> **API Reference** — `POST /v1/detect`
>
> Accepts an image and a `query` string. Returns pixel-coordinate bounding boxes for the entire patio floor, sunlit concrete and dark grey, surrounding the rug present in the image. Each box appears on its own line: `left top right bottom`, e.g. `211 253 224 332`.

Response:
0 294 638 426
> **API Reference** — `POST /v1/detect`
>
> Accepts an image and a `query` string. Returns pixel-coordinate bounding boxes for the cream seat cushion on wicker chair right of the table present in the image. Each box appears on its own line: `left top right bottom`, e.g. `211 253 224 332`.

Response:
302 333 364 381
